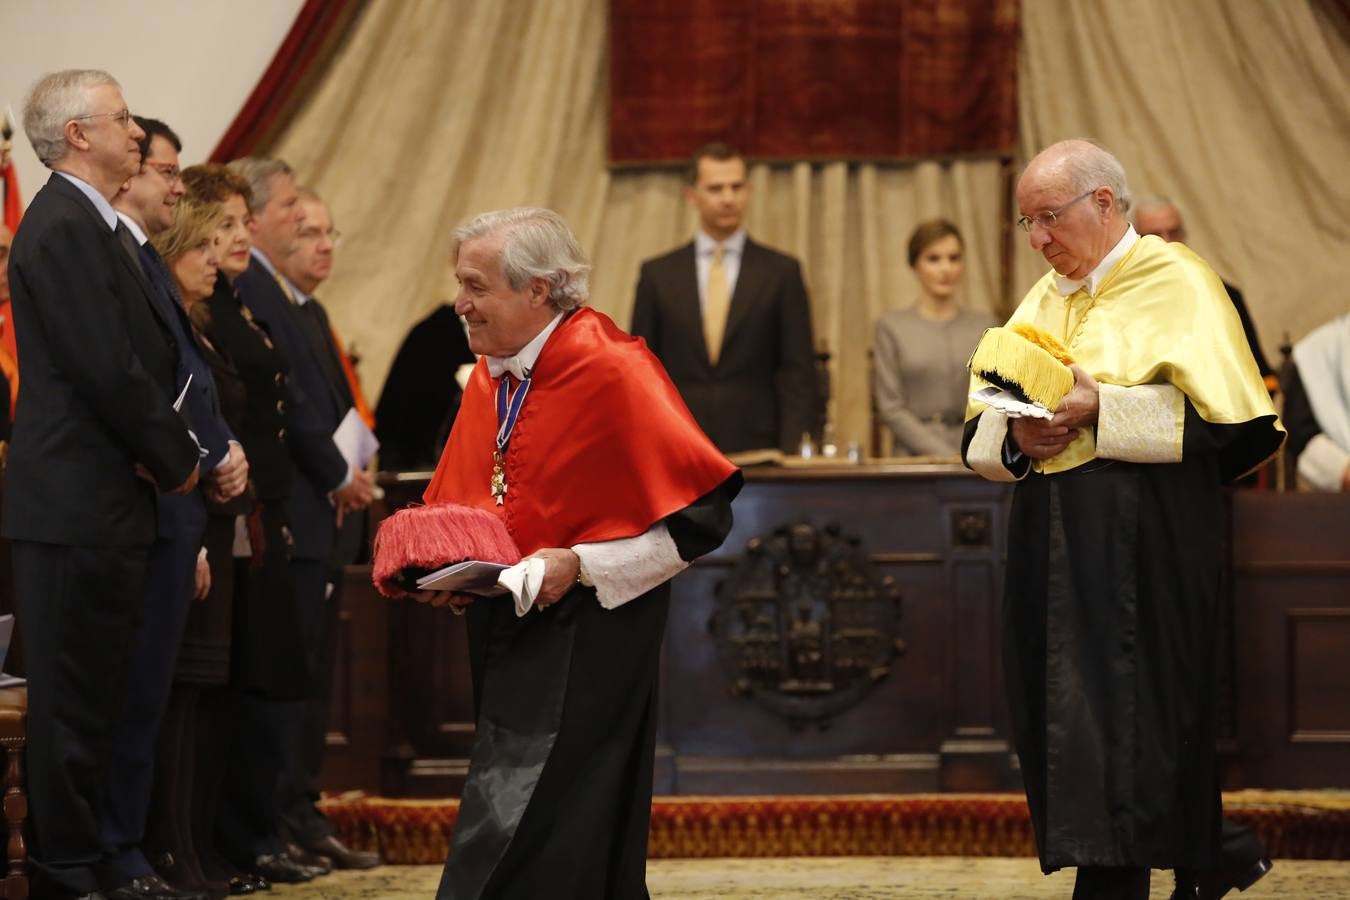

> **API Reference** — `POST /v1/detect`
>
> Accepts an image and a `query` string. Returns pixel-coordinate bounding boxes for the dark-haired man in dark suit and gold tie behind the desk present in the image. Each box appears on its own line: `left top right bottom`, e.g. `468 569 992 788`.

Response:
630 144 817 453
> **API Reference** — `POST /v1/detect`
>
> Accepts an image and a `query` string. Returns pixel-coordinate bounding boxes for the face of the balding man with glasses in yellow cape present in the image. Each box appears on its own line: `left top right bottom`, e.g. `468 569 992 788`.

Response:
1017 169 1114 278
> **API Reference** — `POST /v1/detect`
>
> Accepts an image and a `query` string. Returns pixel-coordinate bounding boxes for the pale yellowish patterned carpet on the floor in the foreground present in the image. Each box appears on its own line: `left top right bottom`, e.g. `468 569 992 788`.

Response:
270 857 1350 900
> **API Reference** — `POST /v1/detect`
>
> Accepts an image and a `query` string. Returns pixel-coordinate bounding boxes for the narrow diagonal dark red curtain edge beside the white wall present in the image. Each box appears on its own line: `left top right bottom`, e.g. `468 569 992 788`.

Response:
211 0 366 162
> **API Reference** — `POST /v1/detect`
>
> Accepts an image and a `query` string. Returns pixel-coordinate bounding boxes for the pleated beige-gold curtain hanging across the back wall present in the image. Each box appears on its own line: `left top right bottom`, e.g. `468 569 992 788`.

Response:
267 0 1350 447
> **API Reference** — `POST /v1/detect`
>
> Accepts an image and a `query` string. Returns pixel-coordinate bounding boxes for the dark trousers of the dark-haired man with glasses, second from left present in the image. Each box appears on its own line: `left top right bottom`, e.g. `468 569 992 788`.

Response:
103 533 201 881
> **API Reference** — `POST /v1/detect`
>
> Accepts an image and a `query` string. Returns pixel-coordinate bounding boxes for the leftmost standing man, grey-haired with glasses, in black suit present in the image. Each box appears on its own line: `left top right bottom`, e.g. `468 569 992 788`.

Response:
4 70 200 900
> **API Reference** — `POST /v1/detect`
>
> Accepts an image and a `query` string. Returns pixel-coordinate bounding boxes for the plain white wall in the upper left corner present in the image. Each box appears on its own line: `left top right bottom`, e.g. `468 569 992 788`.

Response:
0 0 304 204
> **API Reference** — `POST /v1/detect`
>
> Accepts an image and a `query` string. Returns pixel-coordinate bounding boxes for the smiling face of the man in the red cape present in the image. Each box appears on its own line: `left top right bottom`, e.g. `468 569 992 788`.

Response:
455 235 556 356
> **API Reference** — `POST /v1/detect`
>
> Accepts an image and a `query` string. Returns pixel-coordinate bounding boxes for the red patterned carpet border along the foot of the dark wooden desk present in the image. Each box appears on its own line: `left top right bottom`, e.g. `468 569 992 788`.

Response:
323 791 1350 865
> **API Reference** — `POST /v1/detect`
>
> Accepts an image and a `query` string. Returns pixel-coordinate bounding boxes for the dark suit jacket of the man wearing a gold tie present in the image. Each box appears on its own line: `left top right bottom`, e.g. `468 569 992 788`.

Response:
630 240 817 453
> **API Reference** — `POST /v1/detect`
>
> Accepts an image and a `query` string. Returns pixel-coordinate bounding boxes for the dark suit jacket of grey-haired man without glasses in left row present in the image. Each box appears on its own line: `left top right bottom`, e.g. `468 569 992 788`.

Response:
235 260 350 561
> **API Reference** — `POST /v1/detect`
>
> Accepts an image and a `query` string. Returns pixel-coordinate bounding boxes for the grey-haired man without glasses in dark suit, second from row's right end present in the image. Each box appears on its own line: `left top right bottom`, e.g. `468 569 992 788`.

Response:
225 158 373 881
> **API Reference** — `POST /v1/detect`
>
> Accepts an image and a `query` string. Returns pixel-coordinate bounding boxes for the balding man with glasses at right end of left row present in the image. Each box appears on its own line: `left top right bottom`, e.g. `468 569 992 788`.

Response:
278 188 379 869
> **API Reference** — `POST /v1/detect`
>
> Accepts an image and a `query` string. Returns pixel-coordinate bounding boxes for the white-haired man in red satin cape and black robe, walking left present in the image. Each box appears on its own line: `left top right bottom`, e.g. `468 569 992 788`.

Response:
425 208 741 900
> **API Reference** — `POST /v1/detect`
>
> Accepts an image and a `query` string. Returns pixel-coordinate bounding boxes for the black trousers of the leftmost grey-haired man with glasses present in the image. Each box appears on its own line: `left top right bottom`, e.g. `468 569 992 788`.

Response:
14 541 154 897
